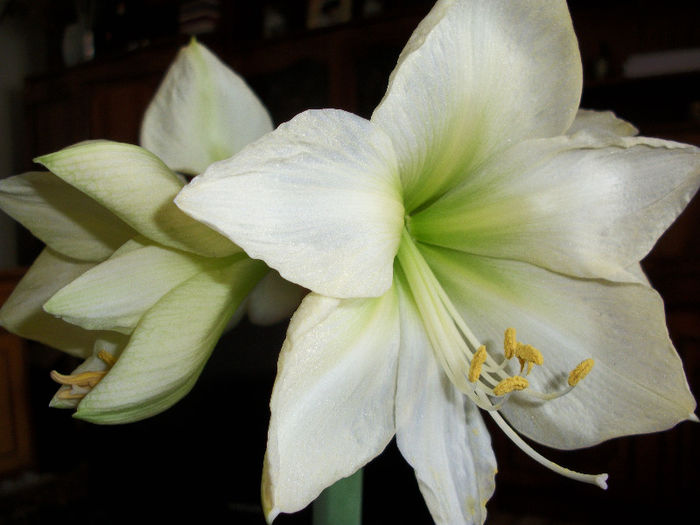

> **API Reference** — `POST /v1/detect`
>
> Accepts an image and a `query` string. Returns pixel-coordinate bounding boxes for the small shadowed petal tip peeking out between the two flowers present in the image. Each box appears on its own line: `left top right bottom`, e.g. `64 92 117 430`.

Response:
248 270 308 326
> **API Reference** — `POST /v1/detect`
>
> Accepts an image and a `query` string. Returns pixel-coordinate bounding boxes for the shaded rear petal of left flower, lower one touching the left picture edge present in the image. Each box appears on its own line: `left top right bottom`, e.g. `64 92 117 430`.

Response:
0 248 112 357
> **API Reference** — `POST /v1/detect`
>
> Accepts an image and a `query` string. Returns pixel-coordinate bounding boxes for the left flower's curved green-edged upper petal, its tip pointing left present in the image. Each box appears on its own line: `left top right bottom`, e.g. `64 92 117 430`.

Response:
36 140 237 256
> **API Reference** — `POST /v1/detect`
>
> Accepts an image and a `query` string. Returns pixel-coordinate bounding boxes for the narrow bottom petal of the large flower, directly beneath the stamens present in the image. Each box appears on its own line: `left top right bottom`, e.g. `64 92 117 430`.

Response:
396 278 496 525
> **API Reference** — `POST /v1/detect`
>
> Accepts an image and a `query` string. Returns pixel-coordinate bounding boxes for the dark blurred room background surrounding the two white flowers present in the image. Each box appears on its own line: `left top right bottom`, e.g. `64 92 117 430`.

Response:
0 0 700 525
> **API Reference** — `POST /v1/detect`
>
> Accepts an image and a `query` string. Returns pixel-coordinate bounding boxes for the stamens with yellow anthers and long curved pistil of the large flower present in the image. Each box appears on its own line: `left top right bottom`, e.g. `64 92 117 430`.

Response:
397 229 607 488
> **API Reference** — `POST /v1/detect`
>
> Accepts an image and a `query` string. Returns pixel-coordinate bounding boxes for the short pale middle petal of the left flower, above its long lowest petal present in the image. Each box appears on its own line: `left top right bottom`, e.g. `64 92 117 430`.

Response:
44 244 215 334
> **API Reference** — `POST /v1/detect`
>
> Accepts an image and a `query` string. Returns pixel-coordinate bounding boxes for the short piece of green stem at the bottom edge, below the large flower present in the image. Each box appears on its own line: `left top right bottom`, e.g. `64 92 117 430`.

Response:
313 469 362 525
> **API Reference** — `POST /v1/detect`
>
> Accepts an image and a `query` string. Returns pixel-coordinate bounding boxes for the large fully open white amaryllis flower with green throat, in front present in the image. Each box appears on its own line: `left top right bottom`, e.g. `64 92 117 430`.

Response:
176 0 700 524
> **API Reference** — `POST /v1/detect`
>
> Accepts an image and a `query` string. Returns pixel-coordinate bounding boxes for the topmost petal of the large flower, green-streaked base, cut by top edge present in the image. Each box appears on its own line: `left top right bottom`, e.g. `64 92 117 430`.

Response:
372 0 582 211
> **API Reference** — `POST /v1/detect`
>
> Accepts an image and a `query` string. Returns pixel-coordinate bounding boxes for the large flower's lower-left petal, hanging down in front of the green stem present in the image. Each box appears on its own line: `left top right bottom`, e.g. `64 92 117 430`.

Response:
263 288 399 522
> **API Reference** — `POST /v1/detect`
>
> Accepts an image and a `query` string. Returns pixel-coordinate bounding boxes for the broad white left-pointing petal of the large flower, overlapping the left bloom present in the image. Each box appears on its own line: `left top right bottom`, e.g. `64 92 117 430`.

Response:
176 110 403 297
